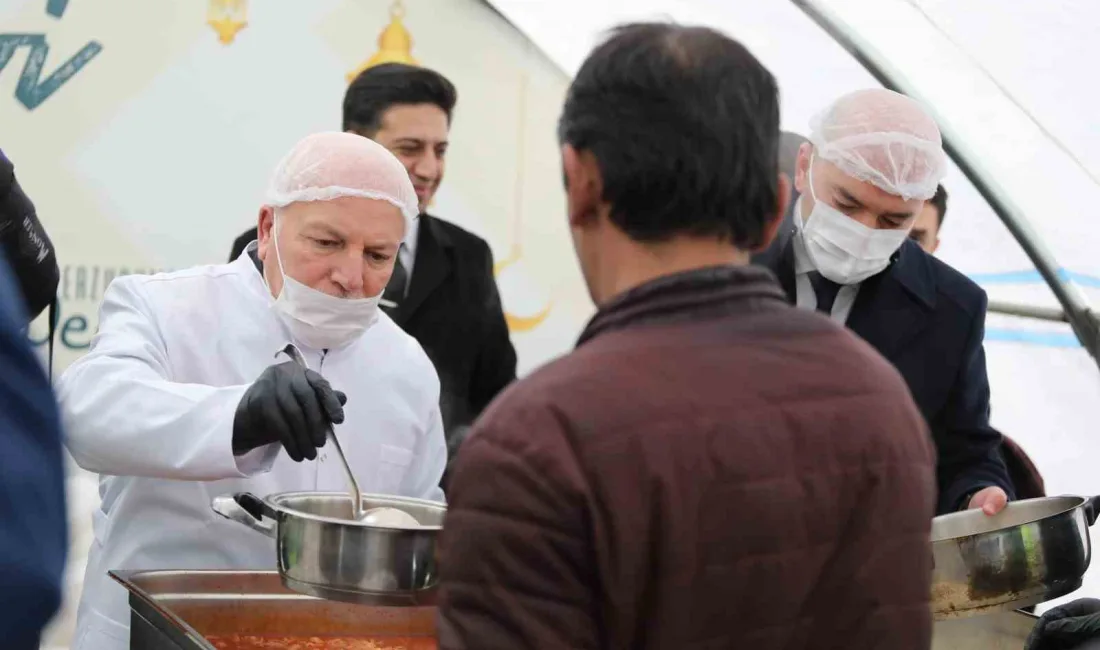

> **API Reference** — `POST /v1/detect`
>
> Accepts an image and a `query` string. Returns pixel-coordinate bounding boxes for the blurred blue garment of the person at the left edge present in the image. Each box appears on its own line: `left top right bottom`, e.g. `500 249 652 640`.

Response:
0 255 68 650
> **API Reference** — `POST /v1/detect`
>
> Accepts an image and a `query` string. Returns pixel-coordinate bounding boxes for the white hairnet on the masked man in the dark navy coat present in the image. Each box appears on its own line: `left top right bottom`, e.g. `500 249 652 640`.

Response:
810 88 947 200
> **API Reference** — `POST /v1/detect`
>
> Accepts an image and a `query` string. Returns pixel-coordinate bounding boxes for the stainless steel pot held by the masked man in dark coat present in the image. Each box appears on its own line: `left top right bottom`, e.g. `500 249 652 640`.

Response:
932 496 1100 620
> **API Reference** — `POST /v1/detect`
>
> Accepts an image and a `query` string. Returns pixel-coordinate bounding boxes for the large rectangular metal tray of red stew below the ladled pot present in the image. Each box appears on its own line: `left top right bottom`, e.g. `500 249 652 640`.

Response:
111 571 436 650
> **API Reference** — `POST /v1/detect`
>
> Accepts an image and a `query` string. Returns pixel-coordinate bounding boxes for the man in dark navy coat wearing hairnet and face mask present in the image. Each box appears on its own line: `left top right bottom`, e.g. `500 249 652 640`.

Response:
755 89 1013 515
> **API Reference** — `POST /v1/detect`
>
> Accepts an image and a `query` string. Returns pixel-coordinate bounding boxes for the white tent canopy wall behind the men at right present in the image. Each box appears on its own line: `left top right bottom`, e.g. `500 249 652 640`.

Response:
491 0 1100 607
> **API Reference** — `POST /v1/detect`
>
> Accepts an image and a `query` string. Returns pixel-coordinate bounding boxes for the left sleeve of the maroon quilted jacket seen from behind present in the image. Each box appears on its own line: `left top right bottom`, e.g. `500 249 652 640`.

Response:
438 405 601 650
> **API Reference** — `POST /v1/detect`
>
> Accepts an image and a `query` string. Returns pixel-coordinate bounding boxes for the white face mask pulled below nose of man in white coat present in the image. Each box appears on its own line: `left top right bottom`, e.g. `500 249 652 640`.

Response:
266 213 385 350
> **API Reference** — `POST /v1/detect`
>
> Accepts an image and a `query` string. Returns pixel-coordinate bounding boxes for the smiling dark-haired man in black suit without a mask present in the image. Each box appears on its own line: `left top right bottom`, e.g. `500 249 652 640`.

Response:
230 64 516 481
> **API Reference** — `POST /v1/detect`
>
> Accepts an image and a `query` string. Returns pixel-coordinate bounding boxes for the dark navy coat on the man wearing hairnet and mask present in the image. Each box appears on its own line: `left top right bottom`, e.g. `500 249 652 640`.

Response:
754 224 1013 514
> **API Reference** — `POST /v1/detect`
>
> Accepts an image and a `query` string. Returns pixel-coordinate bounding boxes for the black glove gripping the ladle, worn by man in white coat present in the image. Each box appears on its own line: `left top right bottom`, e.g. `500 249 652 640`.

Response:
233 361 348 462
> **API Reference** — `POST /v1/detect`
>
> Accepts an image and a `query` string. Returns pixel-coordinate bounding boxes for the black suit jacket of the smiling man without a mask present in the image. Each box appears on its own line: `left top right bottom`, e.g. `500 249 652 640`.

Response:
230 214 516 472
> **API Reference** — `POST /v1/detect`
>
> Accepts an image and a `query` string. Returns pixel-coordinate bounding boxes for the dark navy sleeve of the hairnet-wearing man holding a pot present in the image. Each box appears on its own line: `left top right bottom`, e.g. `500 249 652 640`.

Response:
933 291 1015 514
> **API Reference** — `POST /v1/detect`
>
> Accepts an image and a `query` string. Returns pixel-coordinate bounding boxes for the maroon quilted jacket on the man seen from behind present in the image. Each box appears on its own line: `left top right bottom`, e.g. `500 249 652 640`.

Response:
439 267 935 650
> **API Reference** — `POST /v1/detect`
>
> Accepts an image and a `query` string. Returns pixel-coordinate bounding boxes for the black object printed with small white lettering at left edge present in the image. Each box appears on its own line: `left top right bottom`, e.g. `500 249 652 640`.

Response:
0 153 61 321
